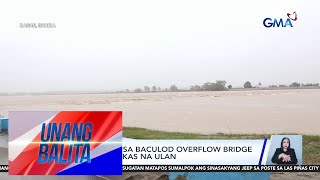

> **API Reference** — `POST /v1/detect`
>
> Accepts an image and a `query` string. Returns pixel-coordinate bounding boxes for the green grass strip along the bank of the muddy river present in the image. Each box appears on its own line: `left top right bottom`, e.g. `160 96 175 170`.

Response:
123 127 320 165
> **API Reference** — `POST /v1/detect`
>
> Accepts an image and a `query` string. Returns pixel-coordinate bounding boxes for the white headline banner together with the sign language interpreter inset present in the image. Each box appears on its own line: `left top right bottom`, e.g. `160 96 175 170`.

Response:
123 135 302 171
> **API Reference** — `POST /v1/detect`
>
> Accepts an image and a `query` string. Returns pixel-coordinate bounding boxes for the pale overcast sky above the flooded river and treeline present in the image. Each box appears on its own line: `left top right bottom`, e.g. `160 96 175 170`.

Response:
0 0 320 92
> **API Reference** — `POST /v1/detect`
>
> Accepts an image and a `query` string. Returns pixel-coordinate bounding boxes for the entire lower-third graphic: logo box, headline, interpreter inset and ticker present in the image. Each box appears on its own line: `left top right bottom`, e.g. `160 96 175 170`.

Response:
0 111 319 175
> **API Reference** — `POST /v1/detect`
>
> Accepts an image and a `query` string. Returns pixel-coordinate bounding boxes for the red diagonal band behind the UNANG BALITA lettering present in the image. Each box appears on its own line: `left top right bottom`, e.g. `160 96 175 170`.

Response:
9 111 122 175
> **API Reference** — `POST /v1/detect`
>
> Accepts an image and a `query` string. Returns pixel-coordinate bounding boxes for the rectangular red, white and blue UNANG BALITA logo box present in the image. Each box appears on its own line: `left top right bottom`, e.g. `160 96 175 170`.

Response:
8 111 122 175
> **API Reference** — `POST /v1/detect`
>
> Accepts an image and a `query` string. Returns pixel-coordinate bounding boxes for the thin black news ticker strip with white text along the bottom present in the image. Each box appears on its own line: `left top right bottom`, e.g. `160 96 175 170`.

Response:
0 165 320 172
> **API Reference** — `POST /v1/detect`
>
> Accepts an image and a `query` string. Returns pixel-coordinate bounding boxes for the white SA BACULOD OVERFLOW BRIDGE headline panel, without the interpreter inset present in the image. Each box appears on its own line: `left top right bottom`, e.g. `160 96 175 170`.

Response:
123 139 266 165
